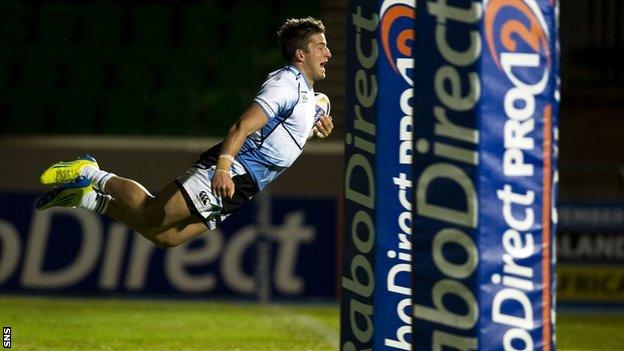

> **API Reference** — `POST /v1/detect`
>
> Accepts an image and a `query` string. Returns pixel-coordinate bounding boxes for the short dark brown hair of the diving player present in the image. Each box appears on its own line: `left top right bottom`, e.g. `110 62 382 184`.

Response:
277 17 325 62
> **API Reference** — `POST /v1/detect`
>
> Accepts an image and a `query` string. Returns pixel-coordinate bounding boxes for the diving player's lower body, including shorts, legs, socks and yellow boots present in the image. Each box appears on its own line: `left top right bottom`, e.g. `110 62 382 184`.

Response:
36 153 236 247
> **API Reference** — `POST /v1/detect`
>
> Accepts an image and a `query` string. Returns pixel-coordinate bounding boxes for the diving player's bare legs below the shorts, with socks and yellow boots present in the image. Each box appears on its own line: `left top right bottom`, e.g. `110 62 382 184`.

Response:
36 155 207 247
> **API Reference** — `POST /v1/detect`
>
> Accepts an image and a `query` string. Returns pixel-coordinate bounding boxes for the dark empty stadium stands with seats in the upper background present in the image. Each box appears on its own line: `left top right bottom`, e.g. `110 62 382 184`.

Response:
0 0 624 200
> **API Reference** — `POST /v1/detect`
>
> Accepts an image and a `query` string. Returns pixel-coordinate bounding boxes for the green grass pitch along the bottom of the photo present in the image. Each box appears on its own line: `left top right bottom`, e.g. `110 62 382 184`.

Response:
0 296 624 351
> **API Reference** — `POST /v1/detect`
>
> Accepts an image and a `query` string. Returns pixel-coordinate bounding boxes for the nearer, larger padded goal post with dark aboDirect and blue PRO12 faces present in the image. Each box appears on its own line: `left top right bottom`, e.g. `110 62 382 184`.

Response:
413 0 558 350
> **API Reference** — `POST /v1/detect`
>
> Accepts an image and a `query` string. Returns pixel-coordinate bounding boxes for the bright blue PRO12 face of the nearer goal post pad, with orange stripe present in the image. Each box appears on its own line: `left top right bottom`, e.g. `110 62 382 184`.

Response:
479 0 559 350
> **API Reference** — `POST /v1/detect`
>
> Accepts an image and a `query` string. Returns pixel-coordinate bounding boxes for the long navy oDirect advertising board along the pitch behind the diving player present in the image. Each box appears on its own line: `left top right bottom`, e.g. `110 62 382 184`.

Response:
0 193 336 298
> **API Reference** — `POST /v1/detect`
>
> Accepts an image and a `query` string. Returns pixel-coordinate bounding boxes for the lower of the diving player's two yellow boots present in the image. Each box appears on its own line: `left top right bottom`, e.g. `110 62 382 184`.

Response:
35 176 93 210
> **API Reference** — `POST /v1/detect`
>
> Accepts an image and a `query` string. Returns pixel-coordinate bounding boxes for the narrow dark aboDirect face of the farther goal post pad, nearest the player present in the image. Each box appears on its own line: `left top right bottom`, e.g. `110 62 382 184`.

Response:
340 0 380 351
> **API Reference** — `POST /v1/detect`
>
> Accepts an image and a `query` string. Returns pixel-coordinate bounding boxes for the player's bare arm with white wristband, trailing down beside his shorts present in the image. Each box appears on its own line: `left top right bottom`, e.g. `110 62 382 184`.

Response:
212 103 268 198
